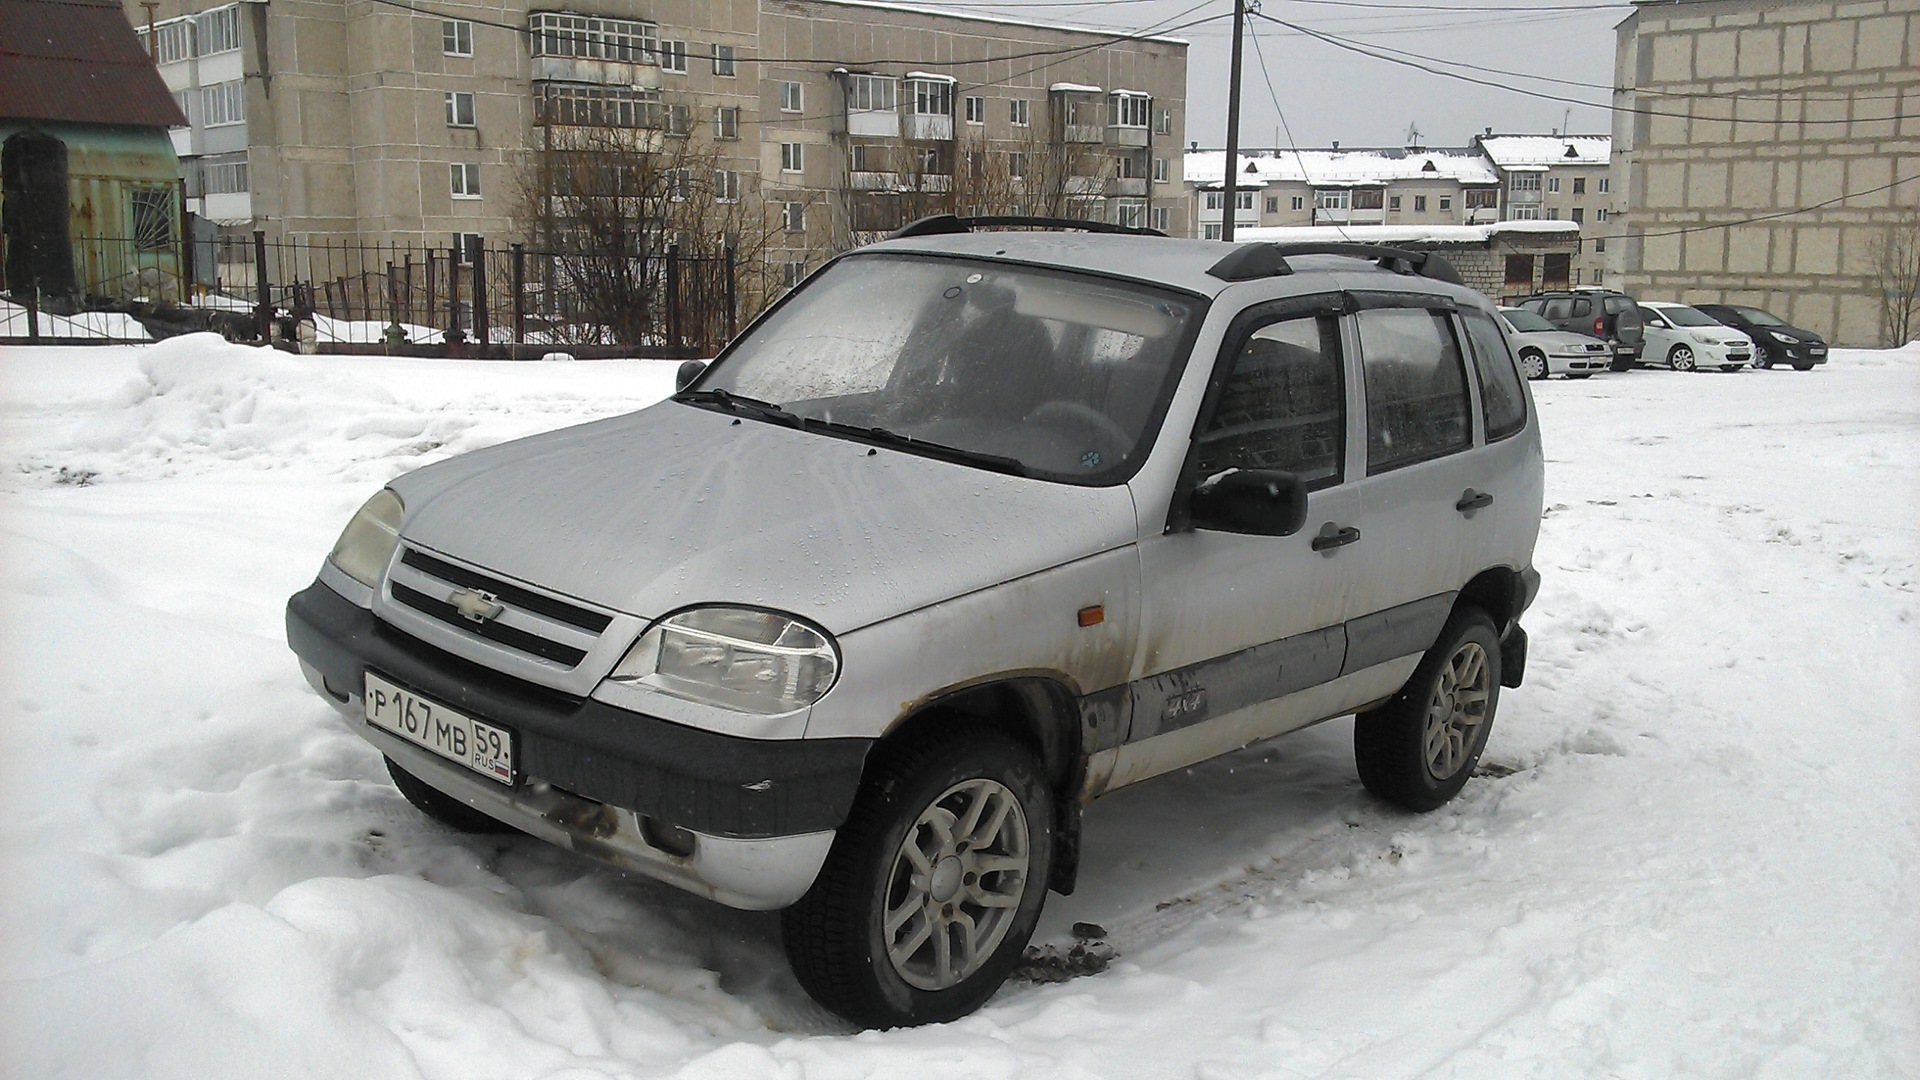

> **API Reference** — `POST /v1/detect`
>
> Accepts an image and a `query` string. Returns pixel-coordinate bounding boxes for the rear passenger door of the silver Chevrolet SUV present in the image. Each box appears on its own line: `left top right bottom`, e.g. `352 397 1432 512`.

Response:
1340 294 1482 684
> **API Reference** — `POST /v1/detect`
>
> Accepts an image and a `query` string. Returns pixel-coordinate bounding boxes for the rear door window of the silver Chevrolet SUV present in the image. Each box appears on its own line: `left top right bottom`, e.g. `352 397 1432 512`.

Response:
1356 307 1473 475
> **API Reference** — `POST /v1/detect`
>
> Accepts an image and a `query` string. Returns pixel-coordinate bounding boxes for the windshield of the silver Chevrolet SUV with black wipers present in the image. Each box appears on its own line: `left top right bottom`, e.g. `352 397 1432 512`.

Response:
682 256 1202 484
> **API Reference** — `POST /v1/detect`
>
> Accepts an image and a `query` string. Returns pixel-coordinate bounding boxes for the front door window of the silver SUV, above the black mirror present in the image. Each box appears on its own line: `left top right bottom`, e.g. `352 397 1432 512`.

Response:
1194 315 1346 488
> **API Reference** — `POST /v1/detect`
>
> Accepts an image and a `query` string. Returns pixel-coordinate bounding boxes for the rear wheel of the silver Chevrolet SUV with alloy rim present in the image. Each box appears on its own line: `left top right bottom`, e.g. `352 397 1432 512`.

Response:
1354 607 1500 811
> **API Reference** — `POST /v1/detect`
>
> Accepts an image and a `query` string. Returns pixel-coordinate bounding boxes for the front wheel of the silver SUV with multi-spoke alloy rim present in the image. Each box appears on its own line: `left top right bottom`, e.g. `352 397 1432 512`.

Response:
781 728 1054 1028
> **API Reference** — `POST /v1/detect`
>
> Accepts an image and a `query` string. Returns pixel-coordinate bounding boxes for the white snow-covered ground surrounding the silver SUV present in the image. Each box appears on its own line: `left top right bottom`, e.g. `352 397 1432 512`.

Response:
0 336 1920 1080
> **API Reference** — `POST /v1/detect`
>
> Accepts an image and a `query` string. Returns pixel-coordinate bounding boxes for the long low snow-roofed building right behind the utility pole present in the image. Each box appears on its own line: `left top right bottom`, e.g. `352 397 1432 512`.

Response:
1185 144 1500 240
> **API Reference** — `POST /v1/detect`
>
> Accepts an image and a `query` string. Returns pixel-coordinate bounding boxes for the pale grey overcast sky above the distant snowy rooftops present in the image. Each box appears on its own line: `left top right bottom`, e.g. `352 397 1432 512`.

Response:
906 0 1630 148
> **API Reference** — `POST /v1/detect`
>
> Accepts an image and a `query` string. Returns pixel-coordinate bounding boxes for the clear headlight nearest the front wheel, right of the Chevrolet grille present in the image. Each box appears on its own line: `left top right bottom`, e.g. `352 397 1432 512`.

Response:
609 607 839 715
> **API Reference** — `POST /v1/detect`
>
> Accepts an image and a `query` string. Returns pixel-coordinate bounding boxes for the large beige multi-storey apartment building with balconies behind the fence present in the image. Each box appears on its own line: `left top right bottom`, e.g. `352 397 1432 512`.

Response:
125 0 1188 275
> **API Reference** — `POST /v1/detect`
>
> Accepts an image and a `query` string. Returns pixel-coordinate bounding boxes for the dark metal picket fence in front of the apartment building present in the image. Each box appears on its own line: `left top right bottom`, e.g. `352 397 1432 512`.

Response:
0 233 770 357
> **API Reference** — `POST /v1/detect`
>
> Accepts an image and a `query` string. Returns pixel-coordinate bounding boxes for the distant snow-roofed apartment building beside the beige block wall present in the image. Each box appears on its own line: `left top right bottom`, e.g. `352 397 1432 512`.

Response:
1473 133 1626 284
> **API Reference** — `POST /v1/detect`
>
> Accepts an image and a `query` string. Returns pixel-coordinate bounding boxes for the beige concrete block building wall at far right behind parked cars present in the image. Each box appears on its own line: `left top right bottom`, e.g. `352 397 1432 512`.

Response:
1609 0 1920 346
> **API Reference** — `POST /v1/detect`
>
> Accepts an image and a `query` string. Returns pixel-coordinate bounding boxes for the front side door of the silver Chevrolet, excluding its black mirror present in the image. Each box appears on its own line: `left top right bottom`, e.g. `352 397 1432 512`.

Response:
1113 294 1357 788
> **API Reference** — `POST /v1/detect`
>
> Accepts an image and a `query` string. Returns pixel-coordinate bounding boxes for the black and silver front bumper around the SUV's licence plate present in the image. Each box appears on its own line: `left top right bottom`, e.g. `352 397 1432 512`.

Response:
286 584 870 911
